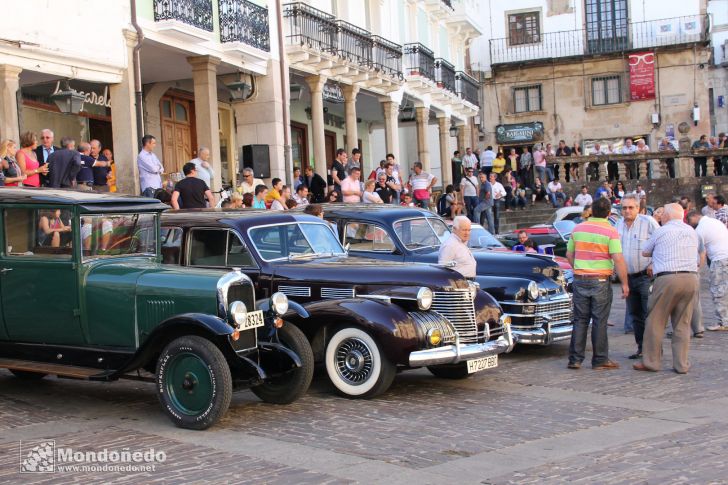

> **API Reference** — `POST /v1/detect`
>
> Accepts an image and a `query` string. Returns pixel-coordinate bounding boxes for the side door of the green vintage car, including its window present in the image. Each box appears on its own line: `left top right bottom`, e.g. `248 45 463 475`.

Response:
0 207 86 345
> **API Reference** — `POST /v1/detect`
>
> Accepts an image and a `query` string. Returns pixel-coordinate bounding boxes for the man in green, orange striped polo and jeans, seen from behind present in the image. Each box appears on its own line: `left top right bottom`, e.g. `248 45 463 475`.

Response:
566 198 629 369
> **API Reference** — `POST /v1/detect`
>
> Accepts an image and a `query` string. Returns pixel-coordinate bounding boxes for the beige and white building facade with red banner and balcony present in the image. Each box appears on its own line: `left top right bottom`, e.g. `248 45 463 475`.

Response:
474 0 711 170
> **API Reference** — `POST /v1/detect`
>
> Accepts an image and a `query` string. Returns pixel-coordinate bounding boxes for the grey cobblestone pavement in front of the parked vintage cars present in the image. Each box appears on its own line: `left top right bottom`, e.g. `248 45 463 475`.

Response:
0 270 728 484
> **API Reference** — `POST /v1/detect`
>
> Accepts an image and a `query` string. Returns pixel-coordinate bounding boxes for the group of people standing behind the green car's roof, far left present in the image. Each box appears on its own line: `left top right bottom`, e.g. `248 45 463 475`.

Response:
0 129 116 192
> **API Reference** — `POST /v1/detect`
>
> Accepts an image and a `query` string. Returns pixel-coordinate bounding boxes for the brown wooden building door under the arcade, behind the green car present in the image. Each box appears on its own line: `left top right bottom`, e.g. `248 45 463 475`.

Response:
160 95 194 173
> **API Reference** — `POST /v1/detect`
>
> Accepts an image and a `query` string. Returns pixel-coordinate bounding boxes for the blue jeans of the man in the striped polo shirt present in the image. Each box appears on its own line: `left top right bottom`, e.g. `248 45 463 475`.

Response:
569 276 612 365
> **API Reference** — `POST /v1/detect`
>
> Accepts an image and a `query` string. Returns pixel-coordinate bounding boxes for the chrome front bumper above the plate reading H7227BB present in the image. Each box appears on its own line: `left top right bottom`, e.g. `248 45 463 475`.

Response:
409 325 515 367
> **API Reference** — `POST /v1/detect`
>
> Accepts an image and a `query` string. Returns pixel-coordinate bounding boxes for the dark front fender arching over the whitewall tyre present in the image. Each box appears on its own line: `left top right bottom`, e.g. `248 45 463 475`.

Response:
288 298 422 365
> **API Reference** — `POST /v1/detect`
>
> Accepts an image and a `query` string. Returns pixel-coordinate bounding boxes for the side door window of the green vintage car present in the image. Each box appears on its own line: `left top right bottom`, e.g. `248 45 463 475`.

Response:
3 208 73 259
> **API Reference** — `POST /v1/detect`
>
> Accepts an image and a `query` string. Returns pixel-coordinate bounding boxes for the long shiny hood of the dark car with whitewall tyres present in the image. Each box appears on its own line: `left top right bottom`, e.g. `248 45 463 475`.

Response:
273 256 467 288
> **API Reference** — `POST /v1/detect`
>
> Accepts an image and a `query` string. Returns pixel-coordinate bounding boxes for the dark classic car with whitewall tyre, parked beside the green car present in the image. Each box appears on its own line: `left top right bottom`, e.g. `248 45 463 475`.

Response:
162 210 513 397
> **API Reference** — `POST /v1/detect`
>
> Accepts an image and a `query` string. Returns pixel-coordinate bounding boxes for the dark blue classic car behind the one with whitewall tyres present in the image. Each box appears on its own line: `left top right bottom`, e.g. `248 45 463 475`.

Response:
324 204 573 345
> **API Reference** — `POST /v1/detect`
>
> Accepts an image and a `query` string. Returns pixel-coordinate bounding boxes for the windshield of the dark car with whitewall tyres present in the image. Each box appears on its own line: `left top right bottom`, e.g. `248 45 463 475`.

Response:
248 222 346 261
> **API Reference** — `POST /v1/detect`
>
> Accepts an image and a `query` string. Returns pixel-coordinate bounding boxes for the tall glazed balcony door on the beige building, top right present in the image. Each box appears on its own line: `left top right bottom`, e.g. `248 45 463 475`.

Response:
585 0 629 54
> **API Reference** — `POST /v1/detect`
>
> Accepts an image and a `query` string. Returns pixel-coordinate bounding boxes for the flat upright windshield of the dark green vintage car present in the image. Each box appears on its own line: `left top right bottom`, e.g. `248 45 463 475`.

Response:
81 214 157 259
